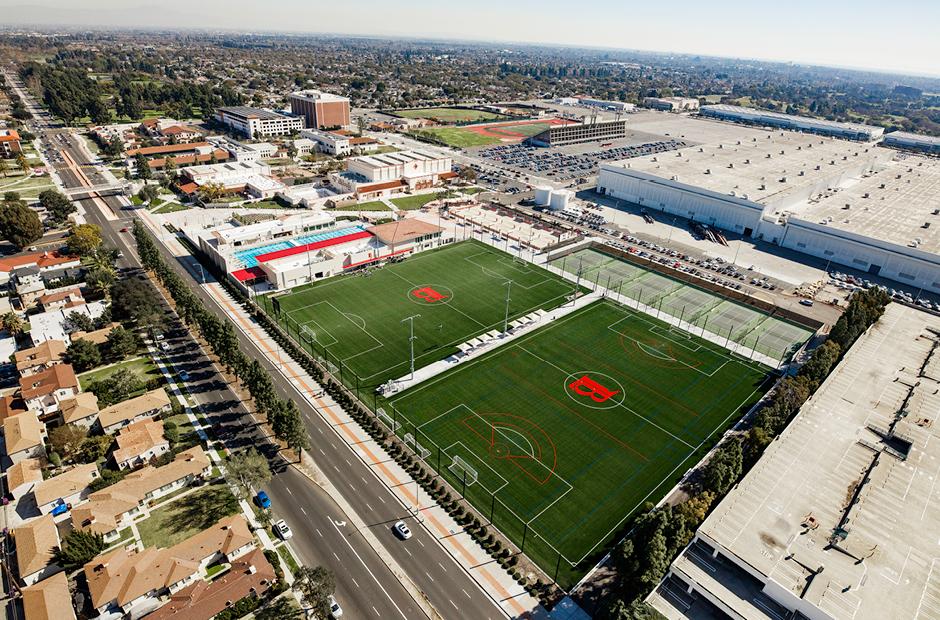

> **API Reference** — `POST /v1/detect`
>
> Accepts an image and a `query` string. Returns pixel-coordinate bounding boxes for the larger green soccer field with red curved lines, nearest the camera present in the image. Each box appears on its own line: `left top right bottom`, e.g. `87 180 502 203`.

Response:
386 300 768 587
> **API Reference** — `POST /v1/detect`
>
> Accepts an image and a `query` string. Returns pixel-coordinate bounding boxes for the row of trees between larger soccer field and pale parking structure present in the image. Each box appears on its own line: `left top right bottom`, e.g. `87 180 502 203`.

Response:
606 289 891 619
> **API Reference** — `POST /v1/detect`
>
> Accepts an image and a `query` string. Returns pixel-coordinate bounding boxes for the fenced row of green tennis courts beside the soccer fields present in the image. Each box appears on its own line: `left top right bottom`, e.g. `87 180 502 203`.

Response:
551 249 813 360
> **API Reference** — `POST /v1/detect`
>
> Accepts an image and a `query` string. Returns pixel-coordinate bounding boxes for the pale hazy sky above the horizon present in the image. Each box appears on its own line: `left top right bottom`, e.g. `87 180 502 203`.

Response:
0 0 940 77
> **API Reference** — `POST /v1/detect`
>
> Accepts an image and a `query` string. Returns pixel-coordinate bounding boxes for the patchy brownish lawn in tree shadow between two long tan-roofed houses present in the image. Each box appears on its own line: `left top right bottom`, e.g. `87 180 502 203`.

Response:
137 483 238 548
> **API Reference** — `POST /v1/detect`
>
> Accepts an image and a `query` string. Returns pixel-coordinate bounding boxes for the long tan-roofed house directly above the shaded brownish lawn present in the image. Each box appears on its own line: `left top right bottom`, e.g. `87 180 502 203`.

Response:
72 446 212 542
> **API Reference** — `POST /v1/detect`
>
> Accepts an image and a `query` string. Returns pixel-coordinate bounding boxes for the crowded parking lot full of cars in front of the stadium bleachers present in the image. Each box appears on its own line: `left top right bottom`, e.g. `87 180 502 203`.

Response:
476 139 688 181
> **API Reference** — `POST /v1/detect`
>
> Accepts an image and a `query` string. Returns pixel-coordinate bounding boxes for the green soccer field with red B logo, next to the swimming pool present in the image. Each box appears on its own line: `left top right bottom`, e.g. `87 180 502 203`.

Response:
264 241 584 394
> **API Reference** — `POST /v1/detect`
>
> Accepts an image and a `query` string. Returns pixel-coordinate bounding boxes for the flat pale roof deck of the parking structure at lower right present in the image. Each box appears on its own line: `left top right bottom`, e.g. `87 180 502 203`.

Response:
692 304 940 620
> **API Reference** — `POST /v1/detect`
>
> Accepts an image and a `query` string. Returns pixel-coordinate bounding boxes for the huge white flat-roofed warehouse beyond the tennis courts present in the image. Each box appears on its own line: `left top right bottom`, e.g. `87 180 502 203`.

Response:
598 132 940 292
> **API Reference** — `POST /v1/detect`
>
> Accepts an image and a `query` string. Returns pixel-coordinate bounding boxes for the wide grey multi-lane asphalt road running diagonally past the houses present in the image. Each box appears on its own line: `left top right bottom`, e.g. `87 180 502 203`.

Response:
12 76 505 619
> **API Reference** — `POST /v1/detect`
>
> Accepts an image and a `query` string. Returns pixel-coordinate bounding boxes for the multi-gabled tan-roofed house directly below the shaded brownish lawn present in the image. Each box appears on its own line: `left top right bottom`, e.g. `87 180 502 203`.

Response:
85 514 255 617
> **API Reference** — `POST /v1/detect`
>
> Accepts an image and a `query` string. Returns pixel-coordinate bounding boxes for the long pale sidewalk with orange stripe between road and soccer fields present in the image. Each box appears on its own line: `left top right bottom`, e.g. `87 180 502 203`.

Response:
138 210 541 617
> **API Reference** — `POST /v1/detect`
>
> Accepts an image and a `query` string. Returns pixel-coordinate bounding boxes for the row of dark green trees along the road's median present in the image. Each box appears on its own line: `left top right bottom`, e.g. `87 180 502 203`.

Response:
134 220 310 458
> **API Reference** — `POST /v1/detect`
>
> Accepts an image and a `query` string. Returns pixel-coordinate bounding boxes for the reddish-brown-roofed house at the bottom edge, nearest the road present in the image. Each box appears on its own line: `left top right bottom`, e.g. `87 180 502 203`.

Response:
147 548 276 620
